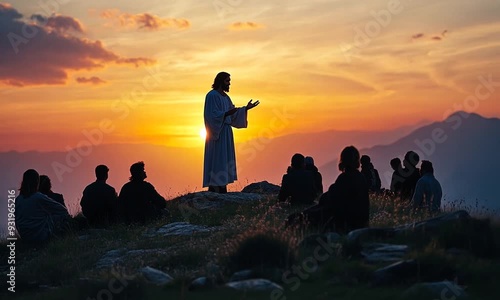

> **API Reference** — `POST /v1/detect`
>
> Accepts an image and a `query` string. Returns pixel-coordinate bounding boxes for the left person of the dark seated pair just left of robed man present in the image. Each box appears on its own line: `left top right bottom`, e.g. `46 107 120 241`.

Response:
80 165 119 226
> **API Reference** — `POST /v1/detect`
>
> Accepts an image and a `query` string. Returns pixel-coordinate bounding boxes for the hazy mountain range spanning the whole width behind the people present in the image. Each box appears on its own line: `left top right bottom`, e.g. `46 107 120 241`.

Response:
0 112 500 234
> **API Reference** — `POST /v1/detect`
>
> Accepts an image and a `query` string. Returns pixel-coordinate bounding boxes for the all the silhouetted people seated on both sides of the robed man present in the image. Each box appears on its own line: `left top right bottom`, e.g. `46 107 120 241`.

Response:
15 146 442 243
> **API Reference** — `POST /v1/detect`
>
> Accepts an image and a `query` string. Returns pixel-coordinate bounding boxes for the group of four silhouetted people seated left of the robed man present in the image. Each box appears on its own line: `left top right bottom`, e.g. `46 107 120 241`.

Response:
15 161 168 243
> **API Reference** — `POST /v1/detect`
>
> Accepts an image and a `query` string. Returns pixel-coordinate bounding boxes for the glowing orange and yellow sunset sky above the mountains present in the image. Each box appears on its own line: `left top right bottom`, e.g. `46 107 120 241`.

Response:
0 0 500 151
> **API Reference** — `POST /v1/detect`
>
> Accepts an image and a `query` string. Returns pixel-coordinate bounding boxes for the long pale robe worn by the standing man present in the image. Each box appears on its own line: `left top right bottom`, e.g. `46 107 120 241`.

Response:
203 90 248 187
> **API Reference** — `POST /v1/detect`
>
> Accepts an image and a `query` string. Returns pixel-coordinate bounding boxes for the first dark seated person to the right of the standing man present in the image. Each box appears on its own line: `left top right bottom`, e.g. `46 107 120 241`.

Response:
278 153 316 204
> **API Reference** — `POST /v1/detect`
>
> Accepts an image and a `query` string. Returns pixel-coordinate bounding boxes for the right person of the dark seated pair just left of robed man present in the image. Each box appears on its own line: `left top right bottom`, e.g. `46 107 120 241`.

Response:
118 161 166 223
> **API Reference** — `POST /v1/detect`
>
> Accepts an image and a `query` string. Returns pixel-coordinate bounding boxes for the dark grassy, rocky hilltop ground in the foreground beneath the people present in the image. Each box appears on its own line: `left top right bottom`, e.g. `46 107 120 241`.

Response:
0 192 500 299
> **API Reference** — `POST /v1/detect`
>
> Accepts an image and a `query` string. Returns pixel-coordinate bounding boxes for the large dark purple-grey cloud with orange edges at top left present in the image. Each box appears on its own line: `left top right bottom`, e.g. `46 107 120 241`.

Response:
0 3 155 86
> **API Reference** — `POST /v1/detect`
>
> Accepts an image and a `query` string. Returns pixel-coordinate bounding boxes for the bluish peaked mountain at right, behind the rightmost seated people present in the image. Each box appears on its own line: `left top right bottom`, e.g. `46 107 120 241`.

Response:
320 112 500 209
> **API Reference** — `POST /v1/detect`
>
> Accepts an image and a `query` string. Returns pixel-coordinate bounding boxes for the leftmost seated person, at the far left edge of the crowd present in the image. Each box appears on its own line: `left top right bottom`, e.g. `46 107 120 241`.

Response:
15 169 71 243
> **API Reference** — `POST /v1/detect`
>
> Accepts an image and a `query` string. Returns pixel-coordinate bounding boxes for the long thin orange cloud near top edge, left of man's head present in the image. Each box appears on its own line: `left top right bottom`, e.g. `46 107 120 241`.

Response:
100 9 191 31
